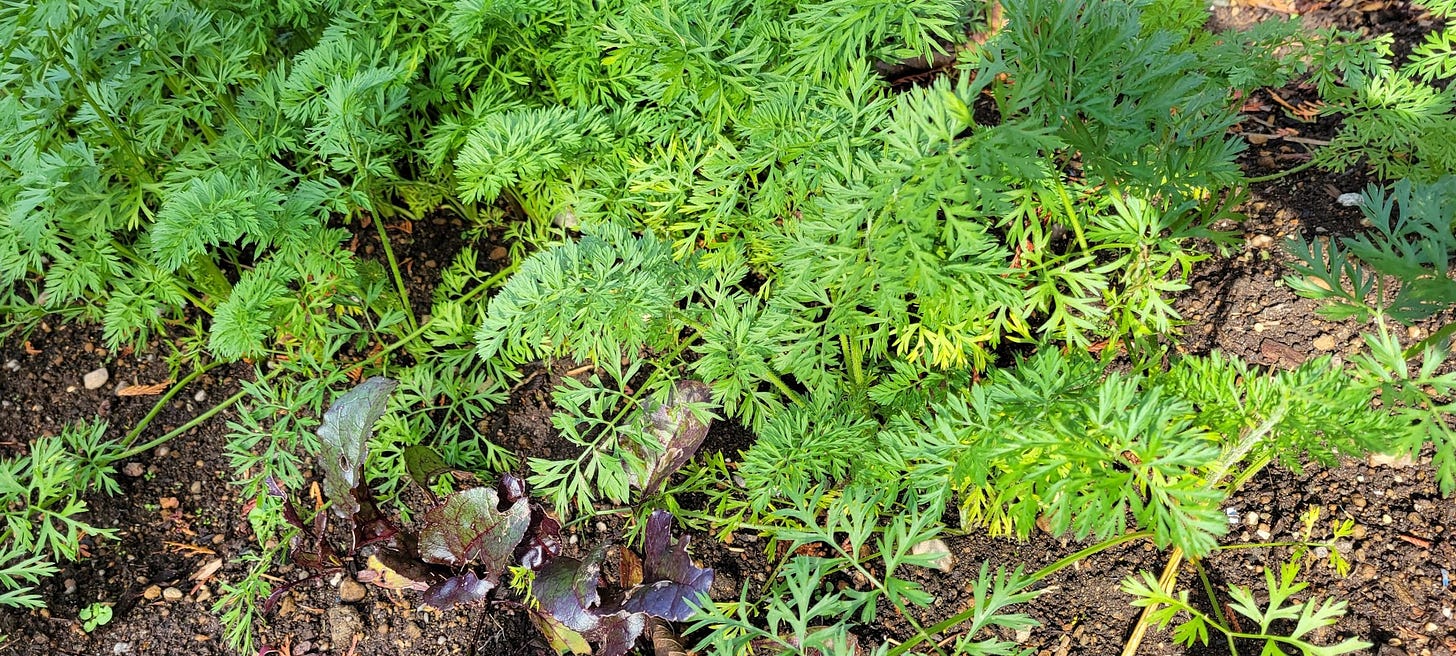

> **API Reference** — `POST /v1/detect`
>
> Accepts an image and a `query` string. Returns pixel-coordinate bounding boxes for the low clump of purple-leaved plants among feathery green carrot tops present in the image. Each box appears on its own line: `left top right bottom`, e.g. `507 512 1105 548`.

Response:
264 377 713 656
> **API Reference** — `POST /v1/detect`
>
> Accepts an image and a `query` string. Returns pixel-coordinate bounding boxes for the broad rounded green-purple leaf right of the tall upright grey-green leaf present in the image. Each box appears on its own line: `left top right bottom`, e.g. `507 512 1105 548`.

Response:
419 487 531 573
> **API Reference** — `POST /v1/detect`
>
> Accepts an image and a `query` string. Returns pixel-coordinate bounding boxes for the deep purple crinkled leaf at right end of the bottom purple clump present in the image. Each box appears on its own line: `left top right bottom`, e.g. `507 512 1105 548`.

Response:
622 511 713 621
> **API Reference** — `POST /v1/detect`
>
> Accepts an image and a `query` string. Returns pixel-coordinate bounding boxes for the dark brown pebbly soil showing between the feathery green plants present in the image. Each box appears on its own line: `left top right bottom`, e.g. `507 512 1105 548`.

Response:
0 0 1456 656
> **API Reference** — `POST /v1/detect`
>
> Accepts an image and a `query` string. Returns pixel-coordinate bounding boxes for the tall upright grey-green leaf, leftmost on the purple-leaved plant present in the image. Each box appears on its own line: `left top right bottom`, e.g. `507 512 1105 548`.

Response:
319 375 397 516
